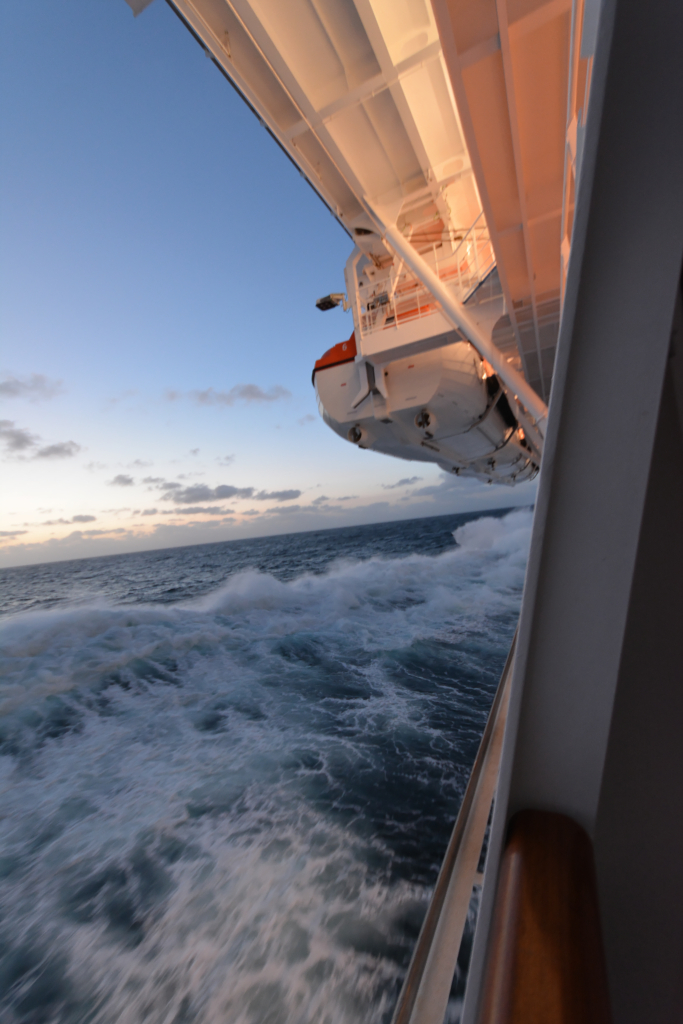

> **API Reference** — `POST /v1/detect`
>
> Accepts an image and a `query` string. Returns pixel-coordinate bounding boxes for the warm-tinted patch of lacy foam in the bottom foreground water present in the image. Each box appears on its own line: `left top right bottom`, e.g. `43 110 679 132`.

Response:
63 808 424 1024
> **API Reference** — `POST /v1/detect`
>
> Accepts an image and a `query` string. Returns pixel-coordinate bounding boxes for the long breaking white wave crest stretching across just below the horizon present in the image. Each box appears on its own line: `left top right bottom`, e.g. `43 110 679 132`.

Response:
0 510 531 707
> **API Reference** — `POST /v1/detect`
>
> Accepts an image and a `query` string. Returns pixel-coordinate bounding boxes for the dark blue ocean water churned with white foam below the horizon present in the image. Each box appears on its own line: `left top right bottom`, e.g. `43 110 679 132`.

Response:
0 510 531 1024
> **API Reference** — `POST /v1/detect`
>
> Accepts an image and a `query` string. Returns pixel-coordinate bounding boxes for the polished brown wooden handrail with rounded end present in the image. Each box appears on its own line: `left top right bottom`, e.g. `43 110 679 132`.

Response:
479 810 611 1024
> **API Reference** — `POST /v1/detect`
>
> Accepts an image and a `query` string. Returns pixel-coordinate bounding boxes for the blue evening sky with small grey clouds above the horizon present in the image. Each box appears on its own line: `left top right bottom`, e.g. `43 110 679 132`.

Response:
0 0 536 566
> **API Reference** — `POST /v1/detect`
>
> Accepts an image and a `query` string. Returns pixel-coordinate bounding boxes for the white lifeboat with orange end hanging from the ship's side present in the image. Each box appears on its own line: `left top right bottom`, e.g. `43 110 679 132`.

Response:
312 334 539 484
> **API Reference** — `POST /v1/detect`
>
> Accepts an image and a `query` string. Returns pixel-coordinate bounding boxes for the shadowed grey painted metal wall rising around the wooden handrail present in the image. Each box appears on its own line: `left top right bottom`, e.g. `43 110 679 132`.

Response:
463 0 683 1011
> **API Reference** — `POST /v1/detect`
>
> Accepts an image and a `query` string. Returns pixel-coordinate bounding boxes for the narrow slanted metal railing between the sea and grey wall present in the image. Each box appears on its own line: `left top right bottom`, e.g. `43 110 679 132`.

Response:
392 633 517 1024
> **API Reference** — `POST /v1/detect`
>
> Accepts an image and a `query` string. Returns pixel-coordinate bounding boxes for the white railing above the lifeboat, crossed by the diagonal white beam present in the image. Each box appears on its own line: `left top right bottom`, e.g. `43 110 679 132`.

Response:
356 213 496 337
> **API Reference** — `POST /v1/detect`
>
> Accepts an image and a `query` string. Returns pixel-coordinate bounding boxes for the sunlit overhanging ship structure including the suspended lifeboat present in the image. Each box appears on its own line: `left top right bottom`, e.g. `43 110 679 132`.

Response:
139 0 594 483
